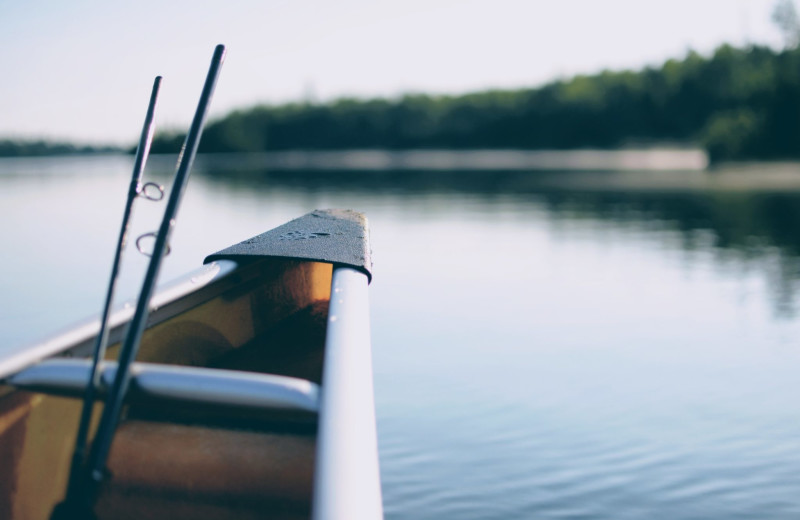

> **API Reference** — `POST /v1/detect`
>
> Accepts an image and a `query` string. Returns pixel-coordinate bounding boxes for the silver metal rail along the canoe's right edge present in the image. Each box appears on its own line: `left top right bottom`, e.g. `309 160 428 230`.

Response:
312 267 383 520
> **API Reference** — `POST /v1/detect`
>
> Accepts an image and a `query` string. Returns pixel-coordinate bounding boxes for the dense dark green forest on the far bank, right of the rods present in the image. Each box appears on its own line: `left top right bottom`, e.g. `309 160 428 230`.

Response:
147 45 800 159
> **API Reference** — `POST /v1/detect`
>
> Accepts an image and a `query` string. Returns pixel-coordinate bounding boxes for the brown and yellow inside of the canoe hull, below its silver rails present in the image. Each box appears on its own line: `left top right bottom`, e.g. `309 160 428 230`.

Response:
0 259 332 520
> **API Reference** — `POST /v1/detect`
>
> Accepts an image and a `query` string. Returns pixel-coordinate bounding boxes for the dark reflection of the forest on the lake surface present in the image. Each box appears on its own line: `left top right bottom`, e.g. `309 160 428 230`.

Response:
189 161 800 319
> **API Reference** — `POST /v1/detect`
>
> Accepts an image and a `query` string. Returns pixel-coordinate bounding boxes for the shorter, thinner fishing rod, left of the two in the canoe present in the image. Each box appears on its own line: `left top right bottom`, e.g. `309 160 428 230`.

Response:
54 76 164 516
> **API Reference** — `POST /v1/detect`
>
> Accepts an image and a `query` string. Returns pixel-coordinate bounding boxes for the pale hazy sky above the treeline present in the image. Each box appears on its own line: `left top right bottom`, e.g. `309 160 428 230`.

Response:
0 0 781 143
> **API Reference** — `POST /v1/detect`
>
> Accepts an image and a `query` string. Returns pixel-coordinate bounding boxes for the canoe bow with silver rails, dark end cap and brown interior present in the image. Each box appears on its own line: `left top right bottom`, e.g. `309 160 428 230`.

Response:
0 210 383 520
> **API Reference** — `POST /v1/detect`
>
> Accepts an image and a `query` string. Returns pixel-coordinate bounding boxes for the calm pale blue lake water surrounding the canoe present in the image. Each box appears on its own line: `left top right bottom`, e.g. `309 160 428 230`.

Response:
0 157 800 520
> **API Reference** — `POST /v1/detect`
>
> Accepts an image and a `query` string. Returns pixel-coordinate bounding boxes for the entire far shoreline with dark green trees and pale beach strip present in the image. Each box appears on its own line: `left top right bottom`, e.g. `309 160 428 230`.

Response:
7 45 800 166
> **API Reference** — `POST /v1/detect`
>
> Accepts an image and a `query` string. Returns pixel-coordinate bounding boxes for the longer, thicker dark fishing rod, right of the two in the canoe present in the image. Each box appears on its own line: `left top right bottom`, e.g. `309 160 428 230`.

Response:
82 45 225 510
